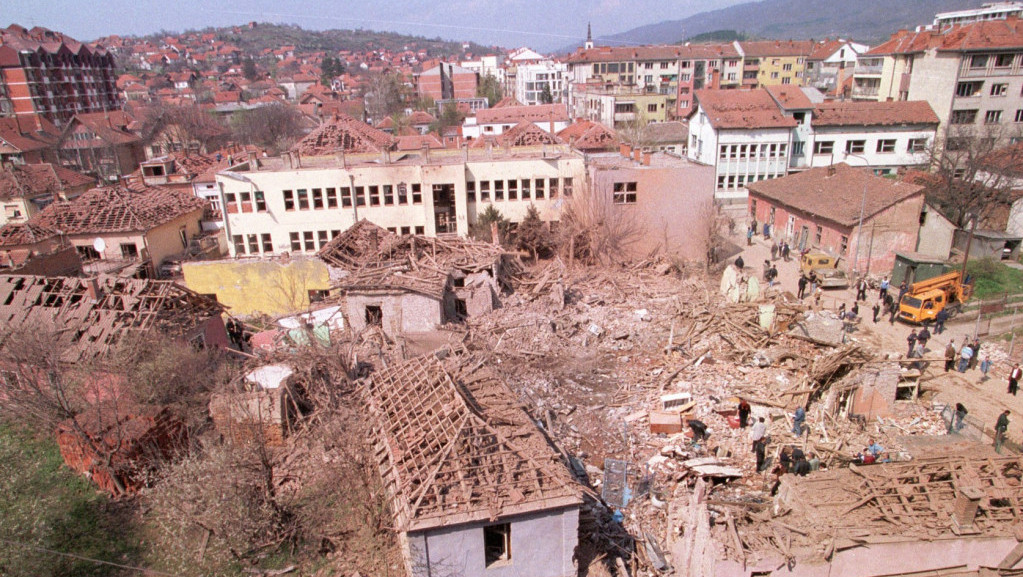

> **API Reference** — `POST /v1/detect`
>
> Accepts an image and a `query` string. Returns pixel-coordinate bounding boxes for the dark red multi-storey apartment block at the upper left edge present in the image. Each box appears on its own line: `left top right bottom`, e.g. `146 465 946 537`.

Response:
0 25 121 126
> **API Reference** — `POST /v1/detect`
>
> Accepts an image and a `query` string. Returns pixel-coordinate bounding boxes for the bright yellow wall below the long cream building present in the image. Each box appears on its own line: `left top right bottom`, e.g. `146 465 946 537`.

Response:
181 259 330 316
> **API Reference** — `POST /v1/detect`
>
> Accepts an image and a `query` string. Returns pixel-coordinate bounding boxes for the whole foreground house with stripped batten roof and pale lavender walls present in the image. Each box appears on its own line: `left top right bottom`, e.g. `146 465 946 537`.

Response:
366 355 582 577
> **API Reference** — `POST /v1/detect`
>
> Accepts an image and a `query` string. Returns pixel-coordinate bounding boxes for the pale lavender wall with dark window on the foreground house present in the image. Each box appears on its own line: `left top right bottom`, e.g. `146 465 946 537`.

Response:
408 507 579 577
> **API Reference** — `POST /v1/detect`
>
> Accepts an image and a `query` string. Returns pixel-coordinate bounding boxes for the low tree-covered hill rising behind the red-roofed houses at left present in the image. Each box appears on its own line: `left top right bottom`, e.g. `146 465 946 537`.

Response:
126 24 495 56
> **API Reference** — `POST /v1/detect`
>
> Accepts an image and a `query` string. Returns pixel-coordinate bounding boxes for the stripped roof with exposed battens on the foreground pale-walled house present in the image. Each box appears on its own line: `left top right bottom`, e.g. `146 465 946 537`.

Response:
367 355 581 531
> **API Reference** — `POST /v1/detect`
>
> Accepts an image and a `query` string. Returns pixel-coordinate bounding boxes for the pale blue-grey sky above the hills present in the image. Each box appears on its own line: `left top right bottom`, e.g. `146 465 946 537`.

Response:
0 0 745 50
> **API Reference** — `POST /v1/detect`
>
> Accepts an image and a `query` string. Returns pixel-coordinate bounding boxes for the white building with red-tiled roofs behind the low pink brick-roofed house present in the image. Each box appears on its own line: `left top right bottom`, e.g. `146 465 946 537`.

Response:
687 86 938 203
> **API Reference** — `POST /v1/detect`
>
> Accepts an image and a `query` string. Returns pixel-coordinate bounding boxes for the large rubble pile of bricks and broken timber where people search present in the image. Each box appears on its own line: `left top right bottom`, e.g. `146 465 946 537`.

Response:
463 261 990 574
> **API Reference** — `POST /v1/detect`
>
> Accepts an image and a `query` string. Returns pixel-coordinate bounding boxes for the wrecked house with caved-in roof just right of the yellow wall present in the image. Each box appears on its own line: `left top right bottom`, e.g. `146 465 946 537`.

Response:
318 220 512 336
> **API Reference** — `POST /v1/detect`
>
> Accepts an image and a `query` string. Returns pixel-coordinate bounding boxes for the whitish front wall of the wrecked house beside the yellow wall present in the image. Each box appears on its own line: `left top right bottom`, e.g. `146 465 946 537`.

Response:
345 291 444 337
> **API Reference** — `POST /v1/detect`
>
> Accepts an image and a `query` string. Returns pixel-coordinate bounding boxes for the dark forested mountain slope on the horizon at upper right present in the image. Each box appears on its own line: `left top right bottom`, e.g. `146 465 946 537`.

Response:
589 0 990 50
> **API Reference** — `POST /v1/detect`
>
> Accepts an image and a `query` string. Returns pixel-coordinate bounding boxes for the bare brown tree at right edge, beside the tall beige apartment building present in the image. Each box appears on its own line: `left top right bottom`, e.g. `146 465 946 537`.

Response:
928 125 1023 227
